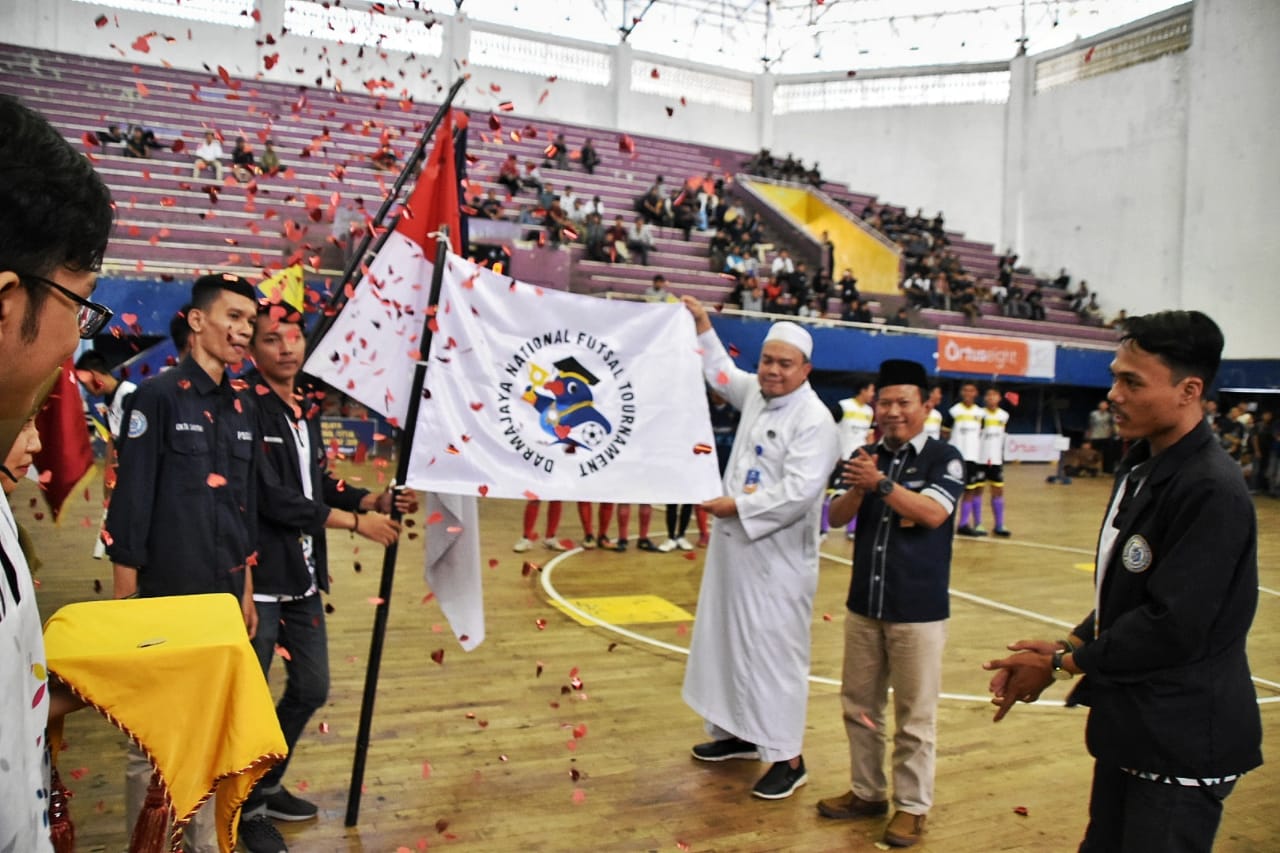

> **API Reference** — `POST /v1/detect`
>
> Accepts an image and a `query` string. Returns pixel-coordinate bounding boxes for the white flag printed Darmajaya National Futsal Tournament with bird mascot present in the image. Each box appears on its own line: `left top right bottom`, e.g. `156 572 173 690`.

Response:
404 255 721 503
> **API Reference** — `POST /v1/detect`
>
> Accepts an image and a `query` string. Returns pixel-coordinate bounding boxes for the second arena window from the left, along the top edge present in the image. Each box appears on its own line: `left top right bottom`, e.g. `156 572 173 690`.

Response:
284 0 444 56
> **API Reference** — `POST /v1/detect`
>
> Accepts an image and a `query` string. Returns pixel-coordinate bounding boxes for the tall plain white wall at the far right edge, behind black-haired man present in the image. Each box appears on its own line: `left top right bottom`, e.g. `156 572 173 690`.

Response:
1181 0 1280 359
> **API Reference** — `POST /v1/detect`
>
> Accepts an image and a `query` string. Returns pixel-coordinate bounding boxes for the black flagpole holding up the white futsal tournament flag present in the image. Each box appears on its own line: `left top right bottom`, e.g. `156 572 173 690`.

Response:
347 225 452 826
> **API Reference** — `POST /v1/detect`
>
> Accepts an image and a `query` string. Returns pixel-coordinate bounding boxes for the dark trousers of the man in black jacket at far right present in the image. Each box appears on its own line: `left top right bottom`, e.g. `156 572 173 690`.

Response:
1080 762 1235 853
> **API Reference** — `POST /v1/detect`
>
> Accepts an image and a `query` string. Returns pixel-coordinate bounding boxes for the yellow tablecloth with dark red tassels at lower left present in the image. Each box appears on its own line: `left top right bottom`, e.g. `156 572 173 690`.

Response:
45 594 287 853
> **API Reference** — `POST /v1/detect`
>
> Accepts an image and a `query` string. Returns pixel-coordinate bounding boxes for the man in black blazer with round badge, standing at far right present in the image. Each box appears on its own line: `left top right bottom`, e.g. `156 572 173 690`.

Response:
986 311 1262 853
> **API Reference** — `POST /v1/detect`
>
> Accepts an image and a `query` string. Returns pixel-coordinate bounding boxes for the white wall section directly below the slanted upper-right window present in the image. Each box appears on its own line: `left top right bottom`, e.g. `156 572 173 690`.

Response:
1016 53 1188 314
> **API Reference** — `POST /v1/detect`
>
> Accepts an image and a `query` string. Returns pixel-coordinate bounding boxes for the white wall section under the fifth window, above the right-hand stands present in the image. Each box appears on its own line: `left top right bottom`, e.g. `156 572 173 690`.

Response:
771 104 1005 243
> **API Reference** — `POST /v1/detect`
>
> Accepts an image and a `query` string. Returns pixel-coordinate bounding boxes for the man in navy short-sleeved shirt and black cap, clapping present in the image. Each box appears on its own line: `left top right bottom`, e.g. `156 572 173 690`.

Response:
818 359 965 847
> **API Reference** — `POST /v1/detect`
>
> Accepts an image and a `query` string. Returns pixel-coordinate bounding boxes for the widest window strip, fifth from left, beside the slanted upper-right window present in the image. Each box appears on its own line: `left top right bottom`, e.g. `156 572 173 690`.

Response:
773 70 1009 115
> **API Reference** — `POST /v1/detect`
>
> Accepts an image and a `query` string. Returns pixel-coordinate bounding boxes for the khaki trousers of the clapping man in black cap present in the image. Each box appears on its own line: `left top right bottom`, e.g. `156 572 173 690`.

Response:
841 612 947 815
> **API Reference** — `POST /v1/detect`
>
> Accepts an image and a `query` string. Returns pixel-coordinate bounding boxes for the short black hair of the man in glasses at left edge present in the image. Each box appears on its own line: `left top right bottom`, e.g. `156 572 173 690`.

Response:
0 95 115 341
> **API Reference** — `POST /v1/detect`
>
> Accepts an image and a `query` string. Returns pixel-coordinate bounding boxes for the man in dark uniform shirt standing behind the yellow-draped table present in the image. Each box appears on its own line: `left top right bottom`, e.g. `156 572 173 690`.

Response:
104 274 259 853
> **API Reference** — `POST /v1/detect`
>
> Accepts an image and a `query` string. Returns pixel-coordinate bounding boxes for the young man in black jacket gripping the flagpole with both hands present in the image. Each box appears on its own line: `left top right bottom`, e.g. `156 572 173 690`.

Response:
241 305 413 853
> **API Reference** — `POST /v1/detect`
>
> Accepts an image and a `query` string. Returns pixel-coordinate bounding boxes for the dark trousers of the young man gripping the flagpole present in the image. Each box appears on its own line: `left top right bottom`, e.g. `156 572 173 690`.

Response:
244 593 329 799
